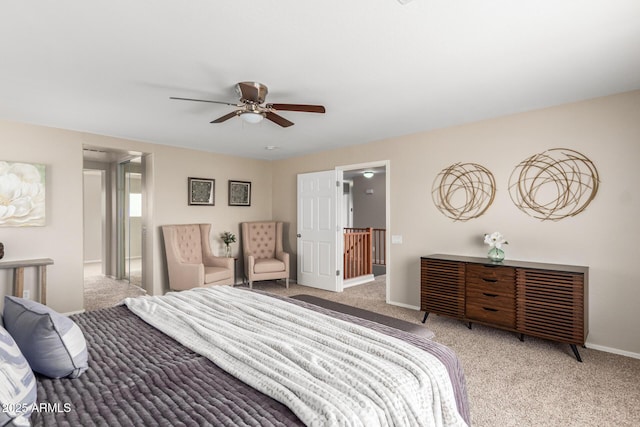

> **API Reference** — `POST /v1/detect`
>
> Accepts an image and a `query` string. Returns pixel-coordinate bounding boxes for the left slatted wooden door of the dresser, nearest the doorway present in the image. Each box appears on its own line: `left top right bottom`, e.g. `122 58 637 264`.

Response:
420 259 465 318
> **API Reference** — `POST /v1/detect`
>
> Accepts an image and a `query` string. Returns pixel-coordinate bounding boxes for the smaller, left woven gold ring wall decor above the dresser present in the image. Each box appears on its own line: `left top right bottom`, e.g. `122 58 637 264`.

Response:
431 163 496 221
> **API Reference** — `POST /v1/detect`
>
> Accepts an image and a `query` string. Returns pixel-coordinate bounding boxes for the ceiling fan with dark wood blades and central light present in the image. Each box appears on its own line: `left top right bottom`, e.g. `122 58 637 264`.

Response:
169 82 325 128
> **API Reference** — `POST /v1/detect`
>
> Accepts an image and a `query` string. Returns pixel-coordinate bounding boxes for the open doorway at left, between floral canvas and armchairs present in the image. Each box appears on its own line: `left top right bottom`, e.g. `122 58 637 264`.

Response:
83 146 153 296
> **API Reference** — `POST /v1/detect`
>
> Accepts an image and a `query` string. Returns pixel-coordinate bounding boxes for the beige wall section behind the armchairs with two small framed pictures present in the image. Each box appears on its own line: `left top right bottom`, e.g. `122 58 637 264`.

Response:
79 134 272 294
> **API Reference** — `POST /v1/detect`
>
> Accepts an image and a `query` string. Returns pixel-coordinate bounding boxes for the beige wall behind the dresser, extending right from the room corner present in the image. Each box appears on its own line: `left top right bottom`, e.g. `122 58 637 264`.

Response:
273 91 640 355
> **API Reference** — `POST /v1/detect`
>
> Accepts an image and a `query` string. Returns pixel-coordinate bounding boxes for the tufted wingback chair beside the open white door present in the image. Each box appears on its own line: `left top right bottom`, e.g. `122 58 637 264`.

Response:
242 221 289 288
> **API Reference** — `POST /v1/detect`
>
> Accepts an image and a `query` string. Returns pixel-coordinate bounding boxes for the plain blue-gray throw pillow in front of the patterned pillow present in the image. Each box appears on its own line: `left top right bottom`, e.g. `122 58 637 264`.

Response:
4 296 89 378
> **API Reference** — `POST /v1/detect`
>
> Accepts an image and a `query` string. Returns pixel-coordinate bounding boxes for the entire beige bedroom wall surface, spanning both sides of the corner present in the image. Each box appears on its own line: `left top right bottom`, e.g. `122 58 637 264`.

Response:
0 91 640 356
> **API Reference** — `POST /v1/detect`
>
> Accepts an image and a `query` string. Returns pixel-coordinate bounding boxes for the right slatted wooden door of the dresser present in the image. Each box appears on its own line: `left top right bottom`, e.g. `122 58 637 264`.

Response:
516 268 586 345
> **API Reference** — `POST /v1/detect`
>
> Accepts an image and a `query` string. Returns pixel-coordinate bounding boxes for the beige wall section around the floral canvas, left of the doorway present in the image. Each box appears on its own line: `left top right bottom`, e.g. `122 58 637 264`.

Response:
0 121 83 312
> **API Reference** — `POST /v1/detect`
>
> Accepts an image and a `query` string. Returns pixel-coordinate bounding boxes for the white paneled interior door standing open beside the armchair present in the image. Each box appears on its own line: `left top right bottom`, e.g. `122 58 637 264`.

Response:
297 170 342 292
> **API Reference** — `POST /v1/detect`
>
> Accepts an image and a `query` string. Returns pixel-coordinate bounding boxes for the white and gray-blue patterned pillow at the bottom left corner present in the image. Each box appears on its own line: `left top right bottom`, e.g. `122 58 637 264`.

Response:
0 326 37 426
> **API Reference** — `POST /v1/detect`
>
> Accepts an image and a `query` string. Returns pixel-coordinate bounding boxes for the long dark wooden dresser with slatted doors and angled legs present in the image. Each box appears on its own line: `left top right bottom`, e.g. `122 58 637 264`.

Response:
420 254 589 362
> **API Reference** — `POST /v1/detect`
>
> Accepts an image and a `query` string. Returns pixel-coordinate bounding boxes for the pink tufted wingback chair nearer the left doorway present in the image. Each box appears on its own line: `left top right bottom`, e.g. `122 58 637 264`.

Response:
162 224 234 291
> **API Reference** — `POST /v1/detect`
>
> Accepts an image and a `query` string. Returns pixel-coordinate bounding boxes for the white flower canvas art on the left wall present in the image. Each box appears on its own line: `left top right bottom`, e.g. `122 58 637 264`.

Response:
0 161 46 227
